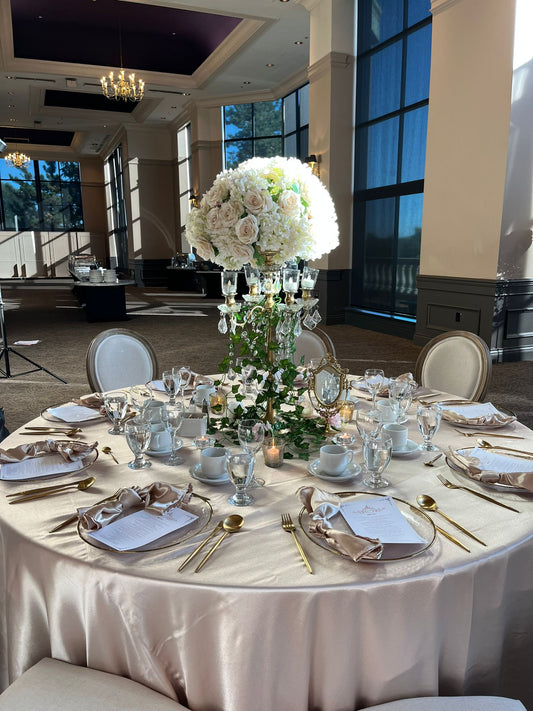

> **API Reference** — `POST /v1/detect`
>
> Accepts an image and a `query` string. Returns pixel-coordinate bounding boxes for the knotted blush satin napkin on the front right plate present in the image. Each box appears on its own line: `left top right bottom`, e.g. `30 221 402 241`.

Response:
298 486 383 563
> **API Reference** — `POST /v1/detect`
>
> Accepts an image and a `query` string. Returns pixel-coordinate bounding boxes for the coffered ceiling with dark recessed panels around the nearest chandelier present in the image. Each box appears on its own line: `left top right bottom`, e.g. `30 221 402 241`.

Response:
0 0 309 155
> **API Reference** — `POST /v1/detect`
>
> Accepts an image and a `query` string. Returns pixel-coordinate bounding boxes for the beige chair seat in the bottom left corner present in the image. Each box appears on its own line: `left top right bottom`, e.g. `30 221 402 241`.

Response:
0 658 186 711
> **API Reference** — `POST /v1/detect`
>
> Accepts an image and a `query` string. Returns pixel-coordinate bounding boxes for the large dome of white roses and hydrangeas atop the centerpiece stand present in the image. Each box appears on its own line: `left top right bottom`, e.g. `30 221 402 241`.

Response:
186 157 339 269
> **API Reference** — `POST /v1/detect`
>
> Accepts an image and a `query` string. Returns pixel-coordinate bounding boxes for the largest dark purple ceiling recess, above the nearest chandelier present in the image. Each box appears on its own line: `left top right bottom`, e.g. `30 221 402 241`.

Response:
11 0 240 75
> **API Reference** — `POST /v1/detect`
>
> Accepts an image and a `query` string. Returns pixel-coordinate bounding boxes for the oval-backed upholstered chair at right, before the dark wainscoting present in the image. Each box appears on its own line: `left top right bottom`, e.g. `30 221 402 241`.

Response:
415 331 492 400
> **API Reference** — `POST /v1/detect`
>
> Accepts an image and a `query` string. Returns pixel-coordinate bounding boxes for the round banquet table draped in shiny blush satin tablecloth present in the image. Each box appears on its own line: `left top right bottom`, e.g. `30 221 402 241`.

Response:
0 395 533 711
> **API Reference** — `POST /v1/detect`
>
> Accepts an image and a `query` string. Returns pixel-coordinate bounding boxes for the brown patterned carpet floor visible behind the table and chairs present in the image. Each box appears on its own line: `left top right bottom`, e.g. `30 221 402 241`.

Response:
0 281 533 430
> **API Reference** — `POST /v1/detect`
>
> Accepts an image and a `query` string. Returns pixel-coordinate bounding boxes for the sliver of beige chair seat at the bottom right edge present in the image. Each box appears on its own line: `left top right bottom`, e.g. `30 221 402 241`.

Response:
361 696 526 711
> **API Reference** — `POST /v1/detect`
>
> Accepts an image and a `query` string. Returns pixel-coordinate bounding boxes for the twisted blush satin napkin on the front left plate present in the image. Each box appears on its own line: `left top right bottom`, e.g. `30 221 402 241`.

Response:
78 481 192 531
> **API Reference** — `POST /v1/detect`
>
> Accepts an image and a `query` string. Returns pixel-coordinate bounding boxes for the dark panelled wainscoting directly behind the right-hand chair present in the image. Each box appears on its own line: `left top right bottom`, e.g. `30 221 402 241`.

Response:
414 275 533 363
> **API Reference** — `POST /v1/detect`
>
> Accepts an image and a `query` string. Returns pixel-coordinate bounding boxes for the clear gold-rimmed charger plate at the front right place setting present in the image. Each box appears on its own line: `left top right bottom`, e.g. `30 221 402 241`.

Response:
298 491 437 563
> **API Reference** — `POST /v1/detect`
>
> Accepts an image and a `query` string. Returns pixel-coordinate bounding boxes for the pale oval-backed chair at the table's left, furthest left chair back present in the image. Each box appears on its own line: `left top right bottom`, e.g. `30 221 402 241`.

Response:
86 328 158 392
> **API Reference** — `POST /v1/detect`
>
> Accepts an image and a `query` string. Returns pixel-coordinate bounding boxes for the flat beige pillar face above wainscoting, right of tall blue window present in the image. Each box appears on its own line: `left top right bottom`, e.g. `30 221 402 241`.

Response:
420 0 514 279
